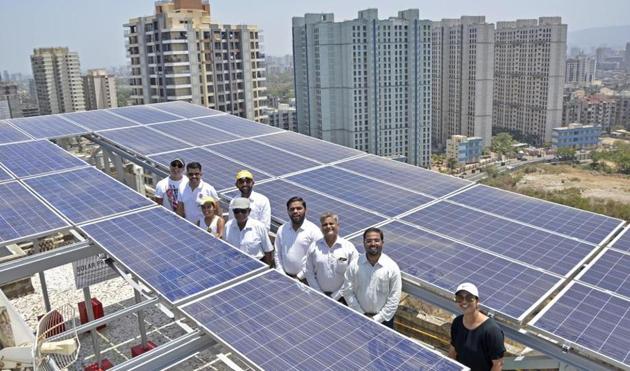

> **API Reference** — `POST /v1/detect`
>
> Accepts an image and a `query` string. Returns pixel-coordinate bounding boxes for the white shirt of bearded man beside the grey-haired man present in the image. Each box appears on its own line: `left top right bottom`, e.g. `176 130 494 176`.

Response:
274 219 323 279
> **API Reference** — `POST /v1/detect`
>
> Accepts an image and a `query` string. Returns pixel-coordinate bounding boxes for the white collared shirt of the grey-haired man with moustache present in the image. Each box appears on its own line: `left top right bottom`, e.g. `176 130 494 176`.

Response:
304 237 359 300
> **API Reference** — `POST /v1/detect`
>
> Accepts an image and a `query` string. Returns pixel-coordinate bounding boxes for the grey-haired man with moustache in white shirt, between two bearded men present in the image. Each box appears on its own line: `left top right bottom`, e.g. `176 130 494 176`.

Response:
305 213 359 304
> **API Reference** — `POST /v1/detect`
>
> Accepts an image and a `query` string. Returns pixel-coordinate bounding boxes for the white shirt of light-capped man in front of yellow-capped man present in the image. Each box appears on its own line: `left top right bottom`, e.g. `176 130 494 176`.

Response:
225 218 273 259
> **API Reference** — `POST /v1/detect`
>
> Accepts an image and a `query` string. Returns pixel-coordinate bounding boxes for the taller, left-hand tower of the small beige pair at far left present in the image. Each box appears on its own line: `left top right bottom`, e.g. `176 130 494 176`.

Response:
31 48 85 115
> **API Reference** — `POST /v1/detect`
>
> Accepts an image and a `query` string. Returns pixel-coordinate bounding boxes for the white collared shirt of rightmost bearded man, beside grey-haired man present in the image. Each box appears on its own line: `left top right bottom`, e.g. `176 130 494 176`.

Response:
341 253 402 322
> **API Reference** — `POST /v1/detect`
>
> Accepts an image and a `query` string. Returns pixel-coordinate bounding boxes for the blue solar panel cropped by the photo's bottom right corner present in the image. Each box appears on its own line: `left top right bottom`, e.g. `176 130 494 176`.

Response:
528 281 630 369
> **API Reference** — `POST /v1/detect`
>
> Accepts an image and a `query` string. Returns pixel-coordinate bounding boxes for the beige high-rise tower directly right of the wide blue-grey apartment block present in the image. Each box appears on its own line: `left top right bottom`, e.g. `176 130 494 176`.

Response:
431 16 494 149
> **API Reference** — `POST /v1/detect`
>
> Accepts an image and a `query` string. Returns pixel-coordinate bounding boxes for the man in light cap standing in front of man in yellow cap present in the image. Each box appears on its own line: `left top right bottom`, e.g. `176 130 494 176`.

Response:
225 197 273 266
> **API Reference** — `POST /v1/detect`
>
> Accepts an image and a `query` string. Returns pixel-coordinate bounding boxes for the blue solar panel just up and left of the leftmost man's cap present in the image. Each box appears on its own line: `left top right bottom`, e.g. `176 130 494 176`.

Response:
99 126 191 155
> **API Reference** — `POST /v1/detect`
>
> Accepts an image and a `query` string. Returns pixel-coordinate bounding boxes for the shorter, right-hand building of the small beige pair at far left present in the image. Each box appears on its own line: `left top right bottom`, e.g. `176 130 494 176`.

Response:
83 69 118 110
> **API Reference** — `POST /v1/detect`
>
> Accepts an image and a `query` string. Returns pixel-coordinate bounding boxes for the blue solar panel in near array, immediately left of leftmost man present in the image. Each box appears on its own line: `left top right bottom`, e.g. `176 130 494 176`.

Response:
26 168 154 224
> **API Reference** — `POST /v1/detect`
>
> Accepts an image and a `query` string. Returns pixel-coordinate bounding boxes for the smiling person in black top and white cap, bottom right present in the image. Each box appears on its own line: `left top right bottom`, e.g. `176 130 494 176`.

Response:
448 282 505 371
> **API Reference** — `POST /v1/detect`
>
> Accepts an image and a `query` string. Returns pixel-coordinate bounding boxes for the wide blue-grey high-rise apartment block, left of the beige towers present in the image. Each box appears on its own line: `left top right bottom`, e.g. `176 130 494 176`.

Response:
293 9 431 166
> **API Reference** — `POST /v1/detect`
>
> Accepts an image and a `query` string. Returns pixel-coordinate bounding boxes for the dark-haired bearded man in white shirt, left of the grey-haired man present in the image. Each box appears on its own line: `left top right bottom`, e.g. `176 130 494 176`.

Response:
274 197 323 281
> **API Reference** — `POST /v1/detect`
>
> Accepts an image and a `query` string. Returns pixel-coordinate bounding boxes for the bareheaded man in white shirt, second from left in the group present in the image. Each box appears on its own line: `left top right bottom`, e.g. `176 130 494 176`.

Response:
177 162 219 224
